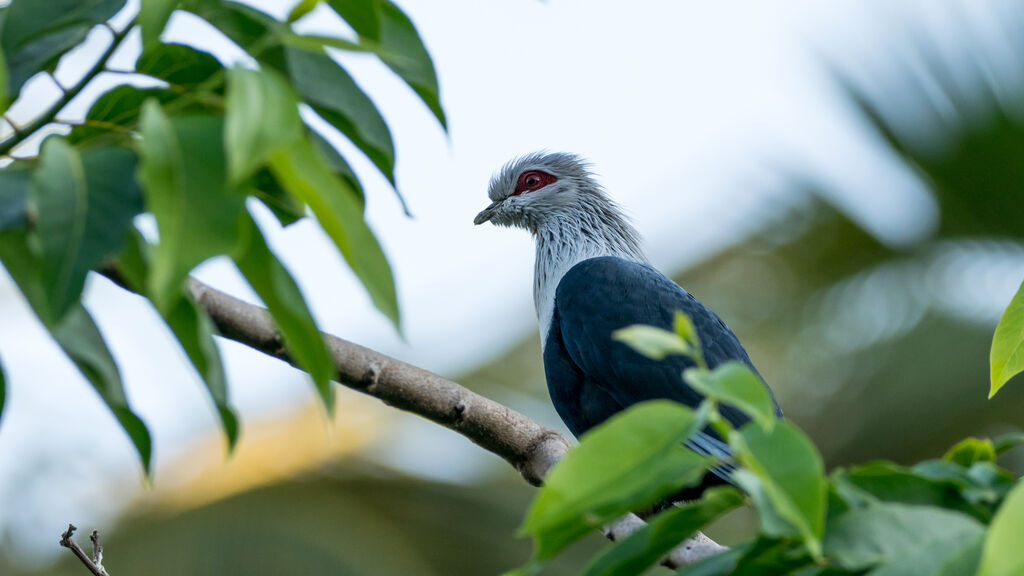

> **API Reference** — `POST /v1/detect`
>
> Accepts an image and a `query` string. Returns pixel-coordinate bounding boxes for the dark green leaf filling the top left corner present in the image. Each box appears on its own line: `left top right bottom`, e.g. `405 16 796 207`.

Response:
0 0 126 96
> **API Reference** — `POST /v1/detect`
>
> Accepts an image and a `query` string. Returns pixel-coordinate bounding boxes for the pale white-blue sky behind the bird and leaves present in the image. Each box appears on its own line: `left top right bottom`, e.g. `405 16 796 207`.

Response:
0 0 1014 559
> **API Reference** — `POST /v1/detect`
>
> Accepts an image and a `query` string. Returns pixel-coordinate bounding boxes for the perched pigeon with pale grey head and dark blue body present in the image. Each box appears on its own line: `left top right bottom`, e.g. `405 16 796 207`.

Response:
474 153 781 499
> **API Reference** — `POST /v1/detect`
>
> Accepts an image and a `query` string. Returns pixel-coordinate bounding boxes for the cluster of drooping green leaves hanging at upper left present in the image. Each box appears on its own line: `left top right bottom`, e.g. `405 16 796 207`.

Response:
0 0 445 471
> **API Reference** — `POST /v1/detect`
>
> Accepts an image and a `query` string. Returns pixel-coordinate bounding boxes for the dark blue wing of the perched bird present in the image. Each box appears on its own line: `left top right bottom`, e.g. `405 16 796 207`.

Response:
544 256 781 483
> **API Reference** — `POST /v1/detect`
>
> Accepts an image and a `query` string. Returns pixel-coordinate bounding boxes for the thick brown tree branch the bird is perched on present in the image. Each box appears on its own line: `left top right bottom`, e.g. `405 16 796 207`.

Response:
100 266 724 569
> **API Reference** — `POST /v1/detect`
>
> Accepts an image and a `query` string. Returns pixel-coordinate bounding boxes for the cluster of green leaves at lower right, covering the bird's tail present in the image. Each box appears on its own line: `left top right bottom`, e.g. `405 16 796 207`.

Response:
519 320 1024 576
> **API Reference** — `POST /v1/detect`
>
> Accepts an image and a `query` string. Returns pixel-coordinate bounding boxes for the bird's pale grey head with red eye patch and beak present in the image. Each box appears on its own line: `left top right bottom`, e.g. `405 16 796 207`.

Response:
473 152 606 233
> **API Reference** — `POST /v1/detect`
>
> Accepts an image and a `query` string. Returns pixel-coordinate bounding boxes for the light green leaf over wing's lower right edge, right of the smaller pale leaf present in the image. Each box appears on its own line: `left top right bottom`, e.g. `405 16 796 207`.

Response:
683 362 778 428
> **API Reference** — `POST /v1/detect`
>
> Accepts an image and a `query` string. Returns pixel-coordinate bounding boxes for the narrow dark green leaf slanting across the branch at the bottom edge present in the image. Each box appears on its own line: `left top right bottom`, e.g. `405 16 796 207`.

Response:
584 487 743 576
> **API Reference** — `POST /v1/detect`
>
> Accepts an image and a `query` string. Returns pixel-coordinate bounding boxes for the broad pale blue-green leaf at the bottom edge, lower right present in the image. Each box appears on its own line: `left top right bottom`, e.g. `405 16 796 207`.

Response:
824 502 985 576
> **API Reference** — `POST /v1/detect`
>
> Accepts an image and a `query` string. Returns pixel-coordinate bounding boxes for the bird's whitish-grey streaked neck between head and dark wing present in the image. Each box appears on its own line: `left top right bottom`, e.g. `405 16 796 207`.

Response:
532 198 647 346
